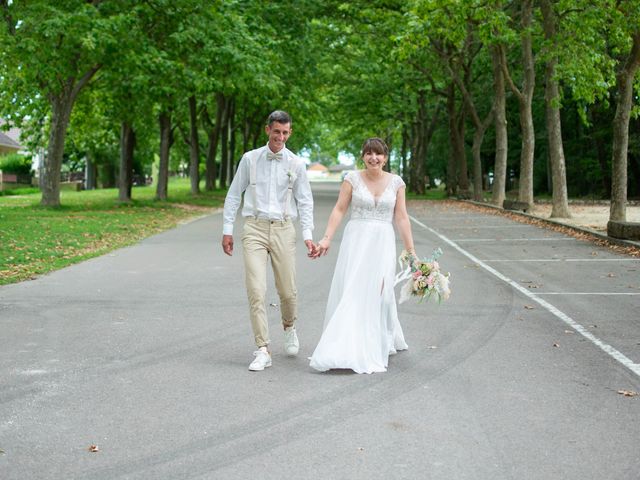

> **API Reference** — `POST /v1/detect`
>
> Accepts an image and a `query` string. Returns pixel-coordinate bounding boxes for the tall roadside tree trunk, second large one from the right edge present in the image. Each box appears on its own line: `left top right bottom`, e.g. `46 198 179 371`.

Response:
540 0 571 218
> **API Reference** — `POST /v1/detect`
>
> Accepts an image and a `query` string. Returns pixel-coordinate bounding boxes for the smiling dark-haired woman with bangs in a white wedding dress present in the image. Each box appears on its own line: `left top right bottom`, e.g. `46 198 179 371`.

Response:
310 138 415 373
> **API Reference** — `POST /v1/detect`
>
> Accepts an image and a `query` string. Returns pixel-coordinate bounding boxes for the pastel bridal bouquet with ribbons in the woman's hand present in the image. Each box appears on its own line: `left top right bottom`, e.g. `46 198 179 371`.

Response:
396 248 451 303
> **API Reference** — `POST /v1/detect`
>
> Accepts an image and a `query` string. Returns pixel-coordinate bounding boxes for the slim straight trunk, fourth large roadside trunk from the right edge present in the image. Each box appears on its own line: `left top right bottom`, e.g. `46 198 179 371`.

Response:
491 45 508 207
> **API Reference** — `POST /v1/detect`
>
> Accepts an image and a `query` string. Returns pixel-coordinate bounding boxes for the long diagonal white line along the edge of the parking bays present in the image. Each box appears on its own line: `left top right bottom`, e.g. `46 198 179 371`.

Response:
409 216 640 377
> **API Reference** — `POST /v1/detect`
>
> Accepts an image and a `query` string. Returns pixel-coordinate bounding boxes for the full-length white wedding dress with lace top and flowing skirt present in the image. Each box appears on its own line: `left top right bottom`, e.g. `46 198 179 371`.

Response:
310 171 408 373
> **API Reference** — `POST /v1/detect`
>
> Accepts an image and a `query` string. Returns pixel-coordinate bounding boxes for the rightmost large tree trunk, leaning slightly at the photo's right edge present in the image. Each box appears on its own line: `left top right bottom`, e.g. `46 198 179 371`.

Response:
609 30 640 222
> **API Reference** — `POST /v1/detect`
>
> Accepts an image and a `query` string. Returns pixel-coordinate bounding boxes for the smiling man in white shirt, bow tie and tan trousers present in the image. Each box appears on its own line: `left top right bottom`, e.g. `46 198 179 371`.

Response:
222 110 316 371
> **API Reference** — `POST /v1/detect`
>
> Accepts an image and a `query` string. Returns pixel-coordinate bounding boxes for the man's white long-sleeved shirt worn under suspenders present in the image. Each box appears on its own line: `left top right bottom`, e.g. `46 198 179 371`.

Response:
222 145 313 240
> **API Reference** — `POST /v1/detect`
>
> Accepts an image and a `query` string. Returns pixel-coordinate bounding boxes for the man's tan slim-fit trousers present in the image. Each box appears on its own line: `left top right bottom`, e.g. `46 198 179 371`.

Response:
242 218 297 347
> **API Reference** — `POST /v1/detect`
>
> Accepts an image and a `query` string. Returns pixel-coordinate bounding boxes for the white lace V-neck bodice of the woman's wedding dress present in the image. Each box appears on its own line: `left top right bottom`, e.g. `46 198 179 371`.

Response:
345 170 404 222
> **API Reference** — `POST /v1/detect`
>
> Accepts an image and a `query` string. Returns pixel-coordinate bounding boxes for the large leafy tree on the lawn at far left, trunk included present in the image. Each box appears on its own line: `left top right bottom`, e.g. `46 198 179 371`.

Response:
0 0 131 206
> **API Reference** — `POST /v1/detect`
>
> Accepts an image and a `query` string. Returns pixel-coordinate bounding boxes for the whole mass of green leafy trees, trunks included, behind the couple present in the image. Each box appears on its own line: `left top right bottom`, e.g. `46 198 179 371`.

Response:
0 0 640 219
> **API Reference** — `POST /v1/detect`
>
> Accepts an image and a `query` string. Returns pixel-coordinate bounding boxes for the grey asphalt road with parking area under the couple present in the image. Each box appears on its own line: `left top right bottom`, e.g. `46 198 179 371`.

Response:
0 184 640 480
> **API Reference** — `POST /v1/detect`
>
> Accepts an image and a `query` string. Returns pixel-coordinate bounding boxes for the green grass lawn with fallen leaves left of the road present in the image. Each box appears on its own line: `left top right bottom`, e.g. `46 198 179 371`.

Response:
0 179 225 285
